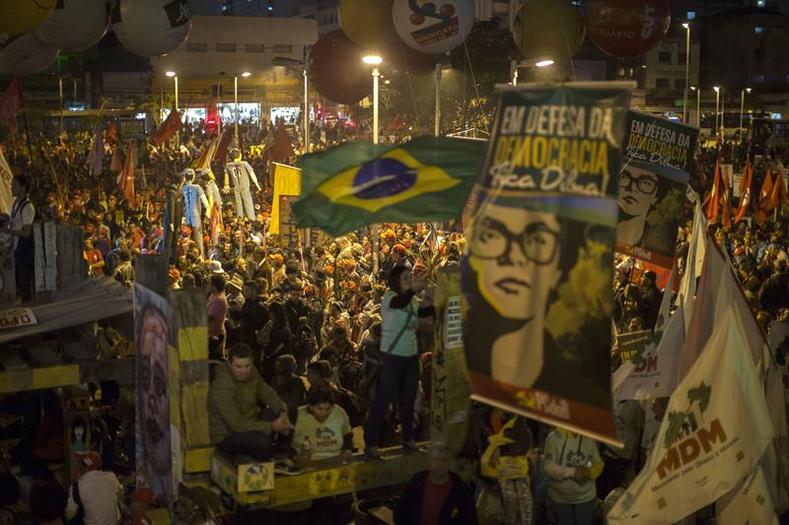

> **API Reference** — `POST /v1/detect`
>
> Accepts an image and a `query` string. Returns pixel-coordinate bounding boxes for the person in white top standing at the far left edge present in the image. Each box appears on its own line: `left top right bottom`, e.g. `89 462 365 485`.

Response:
10 175 36 303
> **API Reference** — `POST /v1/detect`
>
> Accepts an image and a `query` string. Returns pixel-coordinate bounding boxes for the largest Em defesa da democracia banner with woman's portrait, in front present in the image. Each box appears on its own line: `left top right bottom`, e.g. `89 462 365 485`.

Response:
461 83 630 444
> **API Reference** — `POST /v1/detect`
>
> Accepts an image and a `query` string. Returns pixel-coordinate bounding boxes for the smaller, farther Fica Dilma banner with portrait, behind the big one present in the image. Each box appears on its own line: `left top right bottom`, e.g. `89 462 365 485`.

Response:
616 110 699 268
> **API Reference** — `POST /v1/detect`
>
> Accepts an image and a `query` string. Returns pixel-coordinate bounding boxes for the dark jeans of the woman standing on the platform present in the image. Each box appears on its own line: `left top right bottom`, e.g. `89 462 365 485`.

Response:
364 355 419 447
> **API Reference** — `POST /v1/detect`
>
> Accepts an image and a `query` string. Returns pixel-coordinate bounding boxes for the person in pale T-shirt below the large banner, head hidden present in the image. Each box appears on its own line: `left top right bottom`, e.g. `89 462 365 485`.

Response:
544 428 603 525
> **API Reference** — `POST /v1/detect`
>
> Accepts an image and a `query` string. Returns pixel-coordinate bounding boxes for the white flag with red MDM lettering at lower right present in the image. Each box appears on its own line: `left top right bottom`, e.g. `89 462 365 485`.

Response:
608 308 773 525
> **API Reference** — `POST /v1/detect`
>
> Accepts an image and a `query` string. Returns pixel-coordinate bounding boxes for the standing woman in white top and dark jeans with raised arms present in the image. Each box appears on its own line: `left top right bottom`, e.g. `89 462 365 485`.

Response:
364 266 434 459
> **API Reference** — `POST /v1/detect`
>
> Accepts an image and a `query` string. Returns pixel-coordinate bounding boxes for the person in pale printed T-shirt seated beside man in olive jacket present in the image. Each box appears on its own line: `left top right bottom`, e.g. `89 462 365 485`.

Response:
293 387 353 462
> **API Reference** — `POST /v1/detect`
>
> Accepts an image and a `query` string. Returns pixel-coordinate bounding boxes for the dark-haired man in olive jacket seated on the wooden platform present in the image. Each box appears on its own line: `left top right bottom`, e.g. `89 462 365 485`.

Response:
208 343 294 461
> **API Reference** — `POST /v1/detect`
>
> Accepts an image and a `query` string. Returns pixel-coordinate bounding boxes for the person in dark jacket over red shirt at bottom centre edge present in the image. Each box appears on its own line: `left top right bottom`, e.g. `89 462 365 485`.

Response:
394 442 477 525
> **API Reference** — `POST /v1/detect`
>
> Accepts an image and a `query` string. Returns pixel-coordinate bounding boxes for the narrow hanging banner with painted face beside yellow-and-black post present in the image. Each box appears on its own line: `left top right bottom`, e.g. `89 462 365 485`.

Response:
134 282 180 502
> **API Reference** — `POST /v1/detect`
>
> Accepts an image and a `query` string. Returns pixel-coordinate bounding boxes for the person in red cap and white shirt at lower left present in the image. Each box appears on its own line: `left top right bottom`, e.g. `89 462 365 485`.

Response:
66 450 123 525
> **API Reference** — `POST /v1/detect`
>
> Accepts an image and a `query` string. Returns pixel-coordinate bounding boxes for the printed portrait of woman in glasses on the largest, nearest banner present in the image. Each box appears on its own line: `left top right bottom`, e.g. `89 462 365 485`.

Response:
461 192 613 405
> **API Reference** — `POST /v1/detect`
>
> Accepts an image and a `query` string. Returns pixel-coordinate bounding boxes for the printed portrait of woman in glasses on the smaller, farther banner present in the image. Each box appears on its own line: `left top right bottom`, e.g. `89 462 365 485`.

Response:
616 165 676 253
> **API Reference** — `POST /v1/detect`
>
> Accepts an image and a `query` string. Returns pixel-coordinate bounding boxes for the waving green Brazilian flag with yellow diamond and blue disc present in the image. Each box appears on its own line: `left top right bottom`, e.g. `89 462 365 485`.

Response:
293 137 487 236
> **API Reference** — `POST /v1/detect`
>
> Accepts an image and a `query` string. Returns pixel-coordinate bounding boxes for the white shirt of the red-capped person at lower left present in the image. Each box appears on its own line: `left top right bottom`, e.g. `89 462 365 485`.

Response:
66 470 123 525
